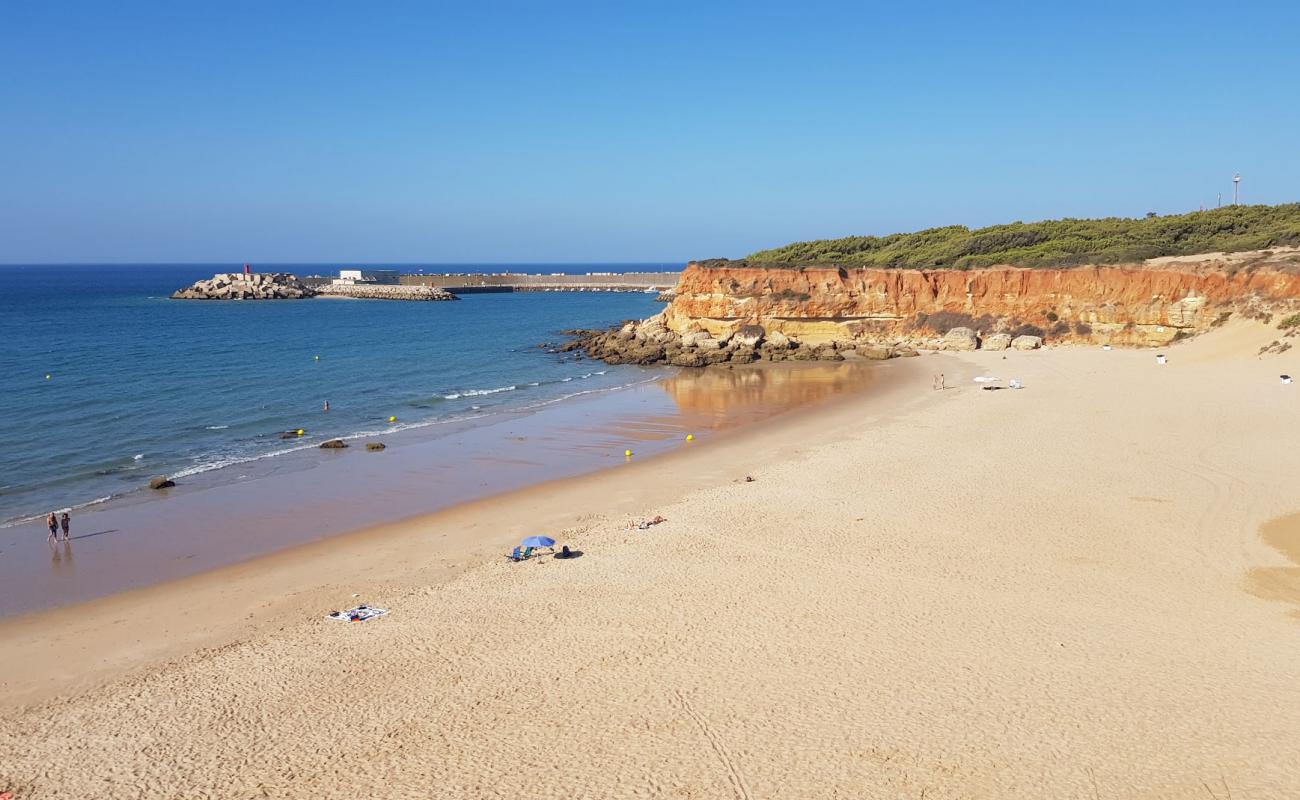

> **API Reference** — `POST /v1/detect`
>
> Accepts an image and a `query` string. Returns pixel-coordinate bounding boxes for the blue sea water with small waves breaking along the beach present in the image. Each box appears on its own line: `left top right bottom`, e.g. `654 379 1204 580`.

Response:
0 264 662 524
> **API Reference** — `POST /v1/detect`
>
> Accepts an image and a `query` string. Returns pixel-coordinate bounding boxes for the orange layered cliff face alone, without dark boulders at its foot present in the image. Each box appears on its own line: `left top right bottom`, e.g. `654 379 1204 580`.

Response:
662 248 1300 346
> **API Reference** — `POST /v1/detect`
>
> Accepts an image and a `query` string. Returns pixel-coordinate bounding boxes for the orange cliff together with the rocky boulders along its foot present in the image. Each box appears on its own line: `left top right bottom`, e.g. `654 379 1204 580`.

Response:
575 247 1300 367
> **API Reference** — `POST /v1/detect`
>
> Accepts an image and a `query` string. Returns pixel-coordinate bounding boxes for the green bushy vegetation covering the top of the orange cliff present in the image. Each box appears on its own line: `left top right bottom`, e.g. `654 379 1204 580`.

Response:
746 203 1300 269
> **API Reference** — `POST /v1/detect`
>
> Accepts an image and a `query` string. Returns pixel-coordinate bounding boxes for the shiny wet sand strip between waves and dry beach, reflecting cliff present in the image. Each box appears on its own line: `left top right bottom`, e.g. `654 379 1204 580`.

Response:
0 363 874 617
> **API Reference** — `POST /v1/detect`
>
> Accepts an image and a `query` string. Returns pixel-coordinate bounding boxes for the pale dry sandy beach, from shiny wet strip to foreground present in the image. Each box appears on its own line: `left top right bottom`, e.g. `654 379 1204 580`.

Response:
0 324 1300 800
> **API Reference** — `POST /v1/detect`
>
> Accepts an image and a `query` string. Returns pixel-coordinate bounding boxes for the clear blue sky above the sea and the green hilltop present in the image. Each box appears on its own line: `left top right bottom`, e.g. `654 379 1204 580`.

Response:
0 0 1300 263
